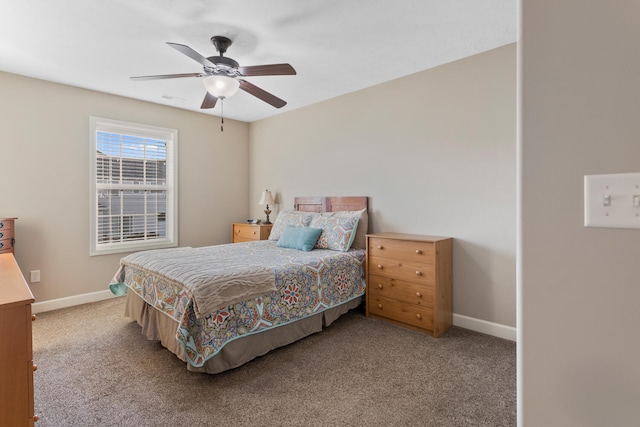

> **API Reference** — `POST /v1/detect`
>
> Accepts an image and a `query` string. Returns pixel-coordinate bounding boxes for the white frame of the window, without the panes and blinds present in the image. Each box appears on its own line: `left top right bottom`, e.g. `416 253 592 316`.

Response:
89 116 178 256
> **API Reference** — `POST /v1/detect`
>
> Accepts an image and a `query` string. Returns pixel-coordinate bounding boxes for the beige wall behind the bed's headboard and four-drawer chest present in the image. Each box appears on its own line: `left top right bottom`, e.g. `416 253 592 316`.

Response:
250 45 516 326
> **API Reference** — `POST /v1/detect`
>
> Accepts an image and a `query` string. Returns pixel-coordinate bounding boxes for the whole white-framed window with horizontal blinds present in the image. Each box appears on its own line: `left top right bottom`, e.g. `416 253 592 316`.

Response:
89 117 178 255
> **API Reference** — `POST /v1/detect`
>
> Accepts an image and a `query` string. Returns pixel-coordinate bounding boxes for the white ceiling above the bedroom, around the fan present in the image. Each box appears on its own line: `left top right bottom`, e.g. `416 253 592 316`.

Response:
0 0 517 122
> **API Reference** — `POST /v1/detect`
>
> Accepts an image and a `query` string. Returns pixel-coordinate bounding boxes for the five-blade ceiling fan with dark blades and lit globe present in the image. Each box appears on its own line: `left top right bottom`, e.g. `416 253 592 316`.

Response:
131 36 296 108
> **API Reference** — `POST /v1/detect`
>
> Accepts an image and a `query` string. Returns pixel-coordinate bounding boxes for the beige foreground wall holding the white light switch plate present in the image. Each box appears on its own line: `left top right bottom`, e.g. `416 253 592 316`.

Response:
519 0 640 427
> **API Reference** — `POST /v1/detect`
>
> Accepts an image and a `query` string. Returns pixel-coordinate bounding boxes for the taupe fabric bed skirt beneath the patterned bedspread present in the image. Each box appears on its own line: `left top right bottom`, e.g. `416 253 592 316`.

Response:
125 292 362 374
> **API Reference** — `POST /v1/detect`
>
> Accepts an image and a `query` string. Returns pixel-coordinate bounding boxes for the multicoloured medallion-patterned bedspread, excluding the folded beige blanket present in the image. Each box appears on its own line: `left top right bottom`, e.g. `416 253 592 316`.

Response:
113 240 365 367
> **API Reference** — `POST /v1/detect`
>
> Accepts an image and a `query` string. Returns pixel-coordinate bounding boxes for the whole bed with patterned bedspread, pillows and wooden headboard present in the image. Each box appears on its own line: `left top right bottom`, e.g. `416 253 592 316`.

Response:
111 197 368 374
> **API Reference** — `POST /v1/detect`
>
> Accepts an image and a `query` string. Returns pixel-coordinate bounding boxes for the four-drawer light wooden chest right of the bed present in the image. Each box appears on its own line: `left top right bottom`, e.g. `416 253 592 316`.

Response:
366 233 453 337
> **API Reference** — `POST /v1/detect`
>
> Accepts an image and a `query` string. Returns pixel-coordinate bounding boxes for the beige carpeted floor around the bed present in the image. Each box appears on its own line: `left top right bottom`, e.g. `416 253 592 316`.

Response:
33 298 516 427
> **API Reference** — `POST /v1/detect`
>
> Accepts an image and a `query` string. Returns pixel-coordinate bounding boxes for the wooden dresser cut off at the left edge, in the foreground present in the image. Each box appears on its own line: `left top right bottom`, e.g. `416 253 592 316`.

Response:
0 253 38 427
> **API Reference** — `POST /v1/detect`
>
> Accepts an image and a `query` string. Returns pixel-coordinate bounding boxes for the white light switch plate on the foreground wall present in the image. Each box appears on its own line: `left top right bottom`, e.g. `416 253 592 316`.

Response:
584 173 640 228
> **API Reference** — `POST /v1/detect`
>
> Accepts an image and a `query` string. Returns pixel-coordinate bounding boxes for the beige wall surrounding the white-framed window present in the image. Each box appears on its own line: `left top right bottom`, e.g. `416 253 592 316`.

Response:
0 73 249 302
